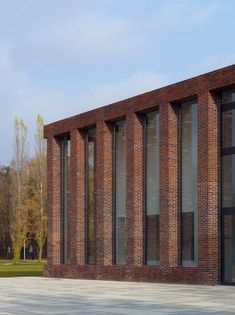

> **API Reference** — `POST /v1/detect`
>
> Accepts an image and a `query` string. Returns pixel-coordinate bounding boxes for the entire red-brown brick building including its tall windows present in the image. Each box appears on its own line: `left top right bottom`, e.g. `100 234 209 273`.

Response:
45 65 235 284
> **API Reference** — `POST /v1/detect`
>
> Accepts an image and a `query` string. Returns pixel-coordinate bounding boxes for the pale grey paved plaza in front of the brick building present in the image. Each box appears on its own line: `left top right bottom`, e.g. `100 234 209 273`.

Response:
0 277 235 315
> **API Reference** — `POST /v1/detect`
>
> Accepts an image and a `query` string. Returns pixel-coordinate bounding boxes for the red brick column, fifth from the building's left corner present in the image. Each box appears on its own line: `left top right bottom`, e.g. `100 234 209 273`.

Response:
160 104 179 268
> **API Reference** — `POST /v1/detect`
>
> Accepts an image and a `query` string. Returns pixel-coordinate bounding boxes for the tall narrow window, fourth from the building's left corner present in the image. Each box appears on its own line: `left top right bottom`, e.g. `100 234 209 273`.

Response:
145 112 160 265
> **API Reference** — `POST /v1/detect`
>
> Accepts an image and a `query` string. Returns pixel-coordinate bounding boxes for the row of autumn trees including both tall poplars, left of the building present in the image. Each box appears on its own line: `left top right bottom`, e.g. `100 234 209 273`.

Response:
0 115 47 262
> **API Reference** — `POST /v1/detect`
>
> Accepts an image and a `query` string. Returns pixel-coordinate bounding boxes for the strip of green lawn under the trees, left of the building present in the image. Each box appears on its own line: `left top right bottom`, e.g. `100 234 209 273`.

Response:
0 259 46 277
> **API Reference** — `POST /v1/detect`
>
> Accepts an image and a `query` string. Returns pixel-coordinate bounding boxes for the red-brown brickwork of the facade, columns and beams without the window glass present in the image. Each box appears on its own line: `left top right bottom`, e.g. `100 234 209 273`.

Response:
45 65 235 284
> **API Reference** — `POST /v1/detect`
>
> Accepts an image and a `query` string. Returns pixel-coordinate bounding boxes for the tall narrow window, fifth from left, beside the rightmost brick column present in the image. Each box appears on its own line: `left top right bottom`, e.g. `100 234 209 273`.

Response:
181 101 198 266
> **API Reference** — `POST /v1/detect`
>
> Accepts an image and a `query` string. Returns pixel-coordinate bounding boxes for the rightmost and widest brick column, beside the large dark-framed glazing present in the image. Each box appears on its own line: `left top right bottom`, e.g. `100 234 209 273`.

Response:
198 92 220 284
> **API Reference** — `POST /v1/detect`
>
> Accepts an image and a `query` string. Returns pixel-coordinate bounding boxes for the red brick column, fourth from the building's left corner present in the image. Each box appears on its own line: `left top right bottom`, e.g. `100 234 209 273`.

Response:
126 113 144 266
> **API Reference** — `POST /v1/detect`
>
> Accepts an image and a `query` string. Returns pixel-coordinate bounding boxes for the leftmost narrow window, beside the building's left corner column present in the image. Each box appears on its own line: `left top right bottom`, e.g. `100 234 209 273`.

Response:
61 137 71 264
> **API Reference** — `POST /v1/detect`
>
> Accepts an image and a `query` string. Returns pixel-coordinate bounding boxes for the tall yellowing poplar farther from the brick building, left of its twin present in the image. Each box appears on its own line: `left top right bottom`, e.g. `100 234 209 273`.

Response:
9 118 29 262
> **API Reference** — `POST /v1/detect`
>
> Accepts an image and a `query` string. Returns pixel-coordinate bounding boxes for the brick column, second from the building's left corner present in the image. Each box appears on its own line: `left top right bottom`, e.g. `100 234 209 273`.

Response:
70 129 85 265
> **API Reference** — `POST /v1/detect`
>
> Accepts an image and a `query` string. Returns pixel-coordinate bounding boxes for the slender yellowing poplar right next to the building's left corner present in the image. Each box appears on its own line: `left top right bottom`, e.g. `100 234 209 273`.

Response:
35 114 47 260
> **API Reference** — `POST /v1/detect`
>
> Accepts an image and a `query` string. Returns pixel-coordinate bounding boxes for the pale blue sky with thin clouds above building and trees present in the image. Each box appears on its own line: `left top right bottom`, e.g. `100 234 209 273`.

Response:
0 0 235 165
